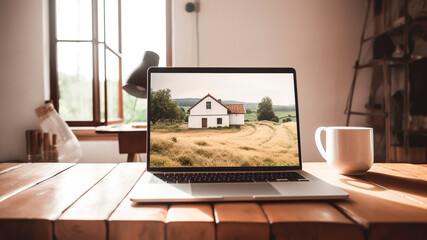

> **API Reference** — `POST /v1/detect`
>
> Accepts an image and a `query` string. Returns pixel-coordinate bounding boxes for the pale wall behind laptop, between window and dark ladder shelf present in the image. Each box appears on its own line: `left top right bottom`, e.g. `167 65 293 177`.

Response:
172 0 367 161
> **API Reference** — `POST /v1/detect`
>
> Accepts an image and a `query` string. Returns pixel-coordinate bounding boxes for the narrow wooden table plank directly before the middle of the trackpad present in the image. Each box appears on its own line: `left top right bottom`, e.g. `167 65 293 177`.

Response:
214 203 270 240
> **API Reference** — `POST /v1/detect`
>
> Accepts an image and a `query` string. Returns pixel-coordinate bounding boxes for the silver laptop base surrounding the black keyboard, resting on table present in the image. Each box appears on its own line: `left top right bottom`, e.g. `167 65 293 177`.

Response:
130 171 348 203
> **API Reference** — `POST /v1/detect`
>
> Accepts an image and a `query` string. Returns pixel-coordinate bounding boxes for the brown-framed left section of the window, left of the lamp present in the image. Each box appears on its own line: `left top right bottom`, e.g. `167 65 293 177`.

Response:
50 0 123 126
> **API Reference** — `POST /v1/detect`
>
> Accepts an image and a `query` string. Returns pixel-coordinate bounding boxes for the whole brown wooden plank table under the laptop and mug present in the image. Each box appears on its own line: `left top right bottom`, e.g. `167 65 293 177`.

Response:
0 163 427 240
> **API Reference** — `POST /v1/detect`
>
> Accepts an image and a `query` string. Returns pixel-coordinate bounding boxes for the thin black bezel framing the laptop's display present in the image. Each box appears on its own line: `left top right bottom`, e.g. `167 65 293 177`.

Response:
146 67 302 172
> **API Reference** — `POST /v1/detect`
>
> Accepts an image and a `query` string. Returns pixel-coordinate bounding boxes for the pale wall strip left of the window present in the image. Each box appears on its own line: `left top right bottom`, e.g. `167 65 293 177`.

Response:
0 0 48 161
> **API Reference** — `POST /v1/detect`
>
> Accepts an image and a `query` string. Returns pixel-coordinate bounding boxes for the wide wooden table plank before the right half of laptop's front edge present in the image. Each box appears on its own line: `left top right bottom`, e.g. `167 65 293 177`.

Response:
261 202 364 240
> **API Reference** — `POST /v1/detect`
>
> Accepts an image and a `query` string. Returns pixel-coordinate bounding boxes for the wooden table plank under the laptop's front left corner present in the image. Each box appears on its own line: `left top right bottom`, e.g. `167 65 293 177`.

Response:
108 166 168 240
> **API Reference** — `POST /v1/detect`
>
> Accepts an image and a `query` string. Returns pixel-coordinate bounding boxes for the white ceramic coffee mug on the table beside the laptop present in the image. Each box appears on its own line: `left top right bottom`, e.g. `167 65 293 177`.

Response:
315 127 374 175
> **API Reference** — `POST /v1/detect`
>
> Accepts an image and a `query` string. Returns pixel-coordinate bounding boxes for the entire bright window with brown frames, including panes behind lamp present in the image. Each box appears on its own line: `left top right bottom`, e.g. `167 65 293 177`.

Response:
49 0 171 126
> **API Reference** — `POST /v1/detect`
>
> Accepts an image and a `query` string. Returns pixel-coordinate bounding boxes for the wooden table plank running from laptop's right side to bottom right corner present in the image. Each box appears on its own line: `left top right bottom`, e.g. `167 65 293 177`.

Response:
304 163 427 239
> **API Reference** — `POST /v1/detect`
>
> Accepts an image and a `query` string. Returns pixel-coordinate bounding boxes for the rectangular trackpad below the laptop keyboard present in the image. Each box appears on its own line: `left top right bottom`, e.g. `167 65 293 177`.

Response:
191 183 280 197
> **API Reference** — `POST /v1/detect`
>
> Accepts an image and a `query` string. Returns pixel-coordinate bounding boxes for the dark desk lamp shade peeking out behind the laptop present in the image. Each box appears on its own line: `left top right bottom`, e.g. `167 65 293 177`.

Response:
123 51 159 98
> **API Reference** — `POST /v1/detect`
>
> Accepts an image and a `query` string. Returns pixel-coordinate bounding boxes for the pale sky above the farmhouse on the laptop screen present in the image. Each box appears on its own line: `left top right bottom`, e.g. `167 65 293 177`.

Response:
151 73 295 105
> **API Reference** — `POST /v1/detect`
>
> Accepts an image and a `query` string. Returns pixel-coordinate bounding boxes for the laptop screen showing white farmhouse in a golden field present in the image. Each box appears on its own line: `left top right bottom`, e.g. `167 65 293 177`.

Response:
147 68 301 171
